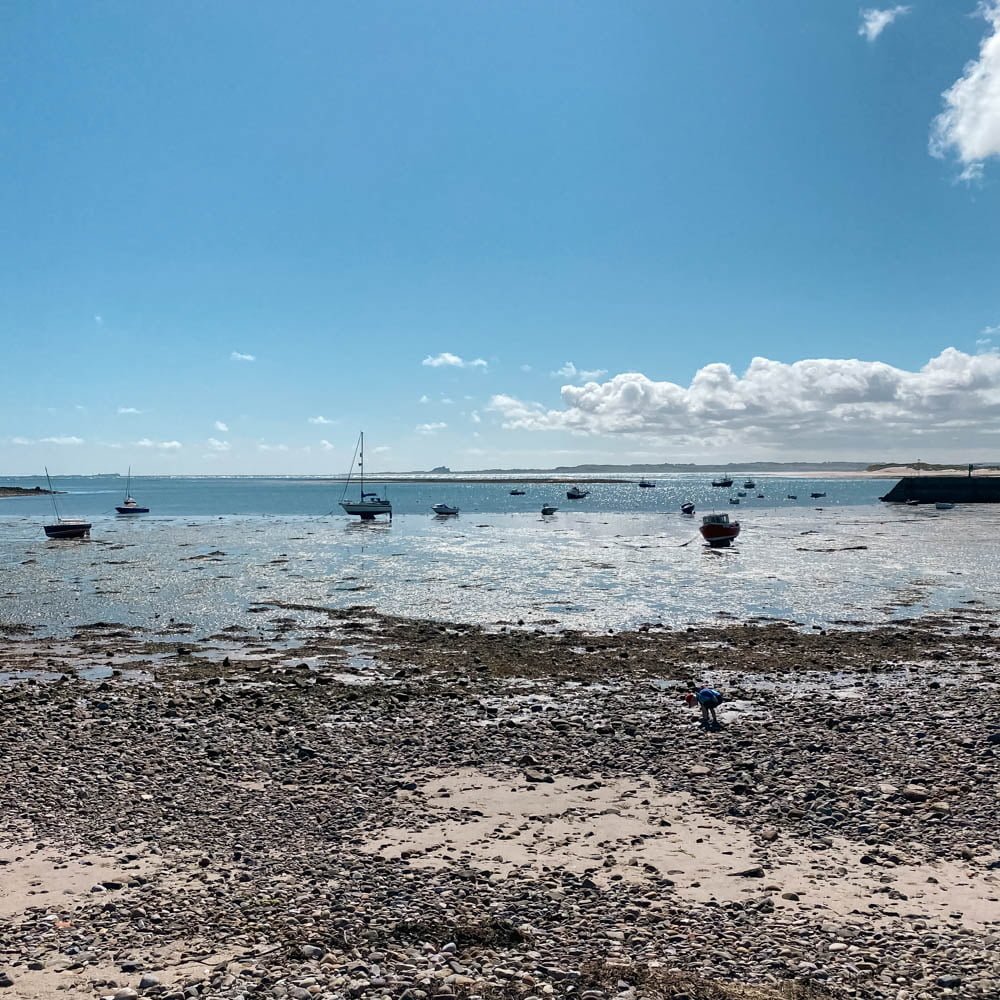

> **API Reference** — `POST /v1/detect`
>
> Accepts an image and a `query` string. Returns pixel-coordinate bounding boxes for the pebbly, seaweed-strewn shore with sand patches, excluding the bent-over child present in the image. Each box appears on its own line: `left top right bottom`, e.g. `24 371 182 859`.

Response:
0 605 1000 1000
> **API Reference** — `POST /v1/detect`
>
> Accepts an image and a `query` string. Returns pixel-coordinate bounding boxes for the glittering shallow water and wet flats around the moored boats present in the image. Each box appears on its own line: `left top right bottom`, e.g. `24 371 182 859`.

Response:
0 477 1000 632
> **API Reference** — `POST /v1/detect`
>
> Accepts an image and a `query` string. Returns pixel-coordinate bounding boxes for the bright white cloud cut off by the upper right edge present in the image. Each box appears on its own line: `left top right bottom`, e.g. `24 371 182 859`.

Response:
930 0 1000 181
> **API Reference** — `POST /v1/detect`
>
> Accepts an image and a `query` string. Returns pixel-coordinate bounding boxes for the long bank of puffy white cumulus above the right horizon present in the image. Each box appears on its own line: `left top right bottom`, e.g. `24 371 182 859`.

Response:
490 347 1000 455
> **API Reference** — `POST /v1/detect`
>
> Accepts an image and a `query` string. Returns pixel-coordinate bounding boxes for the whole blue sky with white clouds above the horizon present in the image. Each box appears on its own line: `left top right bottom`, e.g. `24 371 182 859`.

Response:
0 0 1000 474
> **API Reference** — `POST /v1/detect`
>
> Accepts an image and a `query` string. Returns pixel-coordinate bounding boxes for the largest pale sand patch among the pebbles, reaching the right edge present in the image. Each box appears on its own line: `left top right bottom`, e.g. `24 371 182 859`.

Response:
367 769 1000 929
